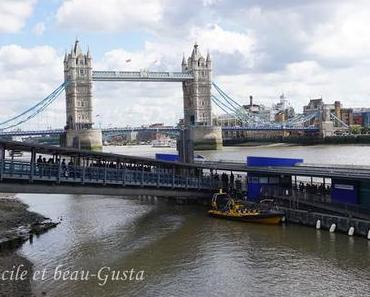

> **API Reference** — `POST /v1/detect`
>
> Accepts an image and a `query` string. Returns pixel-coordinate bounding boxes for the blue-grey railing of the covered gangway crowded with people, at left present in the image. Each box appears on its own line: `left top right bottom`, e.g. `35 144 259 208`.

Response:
0 159 218 190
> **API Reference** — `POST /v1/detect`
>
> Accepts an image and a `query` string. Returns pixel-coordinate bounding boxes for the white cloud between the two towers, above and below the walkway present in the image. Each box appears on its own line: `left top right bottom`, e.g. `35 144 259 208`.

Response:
94 44 183 126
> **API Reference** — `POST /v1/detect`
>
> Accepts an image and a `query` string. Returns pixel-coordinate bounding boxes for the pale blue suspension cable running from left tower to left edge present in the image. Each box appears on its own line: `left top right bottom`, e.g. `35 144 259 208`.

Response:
0 81 69 130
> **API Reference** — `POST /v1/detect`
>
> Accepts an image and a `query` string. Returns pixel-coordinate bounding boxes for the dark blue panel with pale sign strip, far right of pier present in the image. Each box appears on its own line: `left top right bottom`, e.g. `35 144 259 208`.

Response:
331 179 358 204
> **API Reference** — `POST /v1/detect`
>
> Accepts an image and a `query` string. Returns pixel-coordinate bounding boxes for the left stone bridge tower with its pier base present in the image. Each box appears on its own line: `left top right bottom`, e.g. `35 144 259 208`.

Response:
62 40 102 150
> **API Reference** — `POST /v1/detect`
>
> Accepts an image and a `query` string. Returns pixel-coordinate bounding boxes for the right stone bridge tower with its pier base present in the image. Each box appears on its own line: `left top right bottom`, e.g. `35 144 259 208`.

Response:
181 44 222 155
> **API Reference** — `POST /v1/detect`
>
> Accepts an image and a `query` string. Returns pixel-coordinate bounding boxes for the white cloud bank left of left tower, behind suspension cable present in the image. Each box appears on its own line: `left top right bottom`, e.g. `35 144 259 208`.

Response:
0 44 65 129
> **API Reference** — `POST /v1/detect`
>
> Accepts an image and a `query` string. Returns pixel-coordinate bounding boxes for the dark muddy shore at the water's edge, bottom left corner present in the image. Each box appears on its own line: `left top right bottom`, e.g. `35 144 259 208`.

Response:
0 193 56 297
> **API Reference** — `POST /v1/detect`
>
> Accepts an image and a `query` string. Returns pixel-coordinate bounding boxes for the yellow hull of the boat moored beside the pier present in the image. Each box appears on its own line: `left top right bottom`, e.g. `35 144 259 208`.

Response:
208 210 284 225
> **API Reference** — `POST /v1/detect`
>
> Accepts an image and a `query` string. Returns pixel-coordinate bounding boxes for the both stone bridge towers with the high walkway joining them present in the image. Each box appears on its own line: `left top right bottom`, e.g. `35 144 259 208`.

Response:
63 40 222 155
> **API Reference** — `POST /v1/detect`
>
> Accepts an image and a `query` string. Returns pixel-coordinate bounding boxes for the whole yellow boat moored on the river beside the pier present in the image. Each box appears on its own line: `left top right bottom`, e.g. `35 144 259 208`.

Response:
208 193 284 224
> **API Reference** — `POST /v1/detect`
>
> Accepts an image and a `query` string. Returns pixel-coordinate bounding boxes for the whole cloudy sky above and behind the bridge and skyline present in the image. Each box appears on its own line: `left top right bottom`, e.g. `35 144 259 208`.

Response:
0 0 370 128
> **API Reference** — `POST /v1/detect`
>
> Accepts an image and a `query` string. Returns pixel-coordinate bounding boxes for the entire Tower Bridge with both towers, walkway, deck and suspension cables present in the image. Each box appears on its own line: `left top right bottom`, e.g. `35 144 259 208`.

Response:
0 40 348 154
